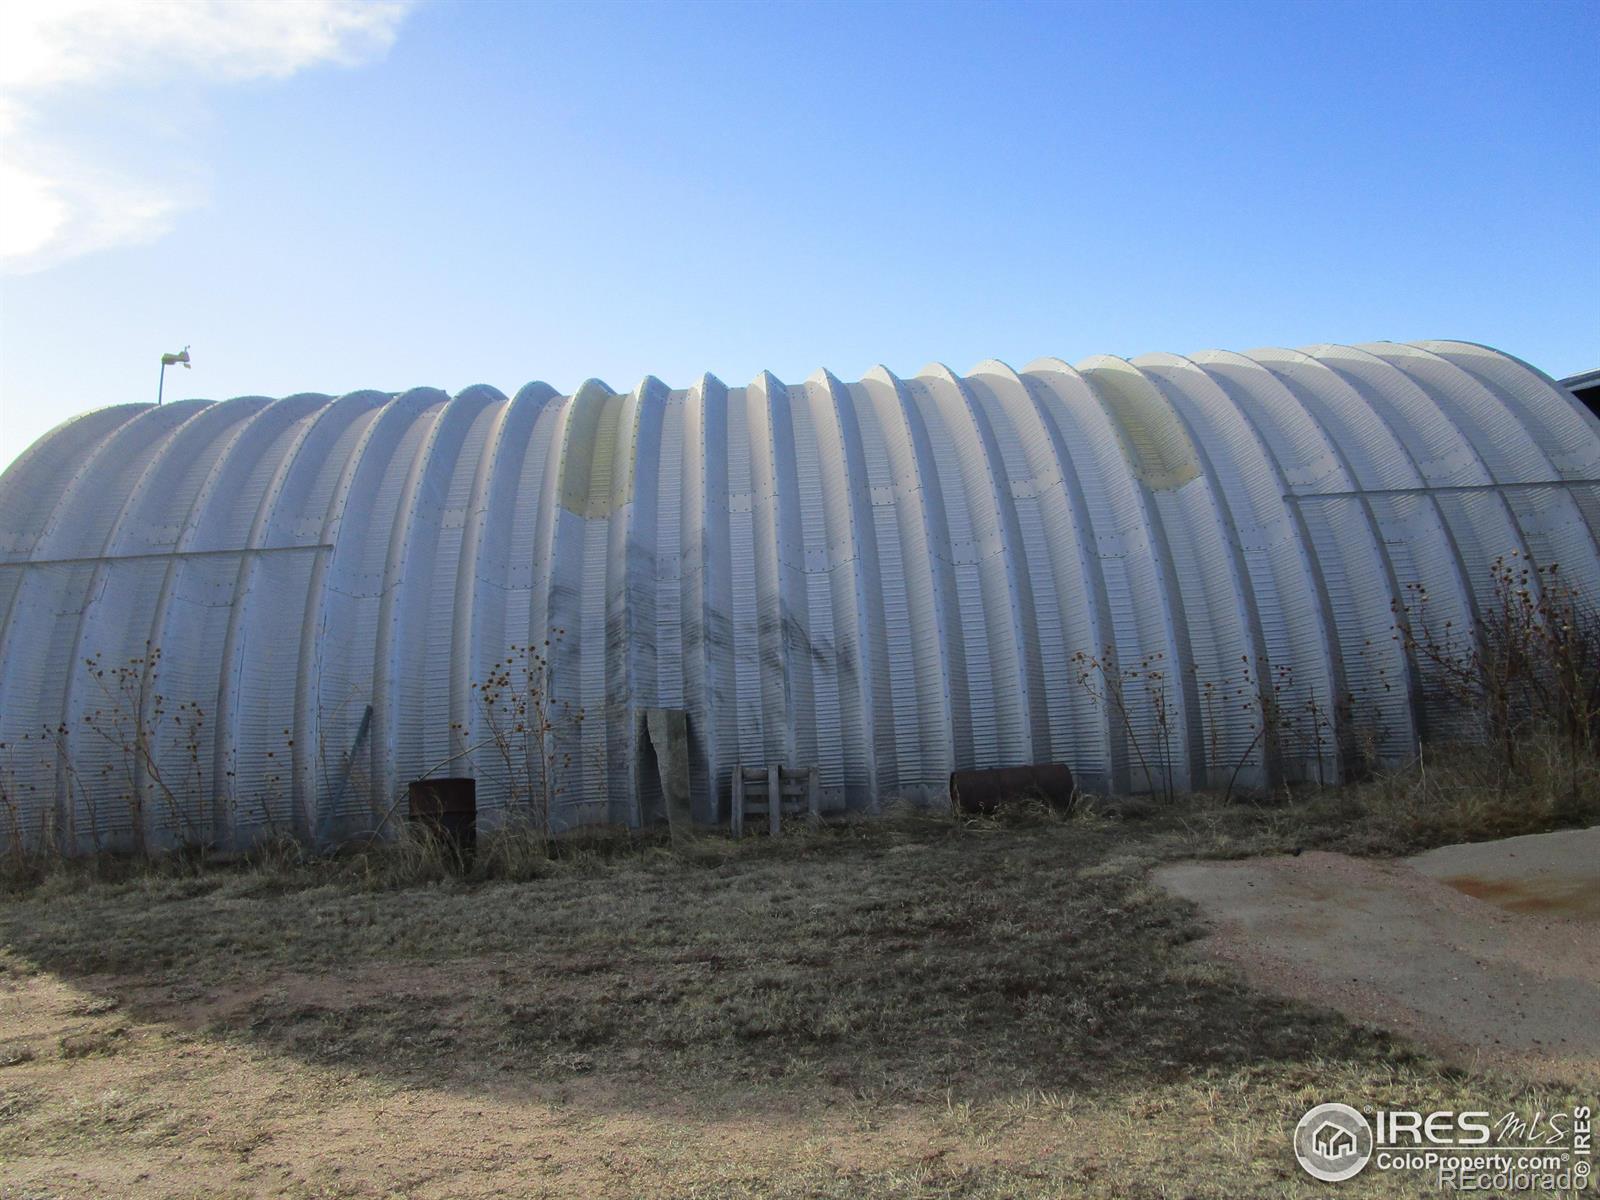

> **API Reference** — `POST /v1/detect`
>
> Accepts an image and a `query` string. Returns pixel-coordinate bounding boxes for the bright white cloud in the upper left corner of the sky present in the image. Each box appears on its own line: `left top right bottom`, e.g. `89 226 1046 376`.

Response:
0 0 413 272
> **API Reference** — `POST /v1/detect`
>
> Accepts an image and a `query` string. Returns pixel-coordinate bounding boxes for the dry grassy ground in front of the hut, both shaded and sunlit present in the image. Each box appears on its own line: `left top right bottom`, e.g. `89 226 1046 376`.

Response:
0 752 1600 1197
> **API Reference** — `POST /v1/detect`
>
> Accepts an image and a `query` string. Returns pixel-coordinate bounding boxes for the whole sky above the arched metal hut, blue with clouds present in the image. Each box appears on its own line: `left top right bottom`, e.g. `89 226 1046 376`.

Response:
0 0 1600 464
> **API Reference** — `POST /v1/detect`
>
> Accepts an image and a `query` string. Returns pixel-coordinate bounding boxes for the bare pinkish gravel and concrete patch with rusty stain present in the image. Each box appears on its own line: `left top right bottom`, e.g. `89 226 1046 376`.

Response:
1155 827 1600 1083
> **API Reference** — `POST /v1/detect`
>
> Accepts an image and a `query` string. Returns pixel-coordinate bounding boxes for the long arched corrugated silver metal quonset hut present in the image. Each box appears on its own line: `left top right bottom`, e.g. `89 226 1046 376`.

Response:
0 342 1600 850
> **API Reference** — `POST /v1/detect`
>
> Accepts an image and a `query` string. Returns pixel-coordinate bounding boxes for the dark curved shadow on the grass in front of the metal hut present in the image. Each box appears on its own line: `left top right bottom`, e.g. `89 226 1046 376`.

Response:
0 811 1405 1104
